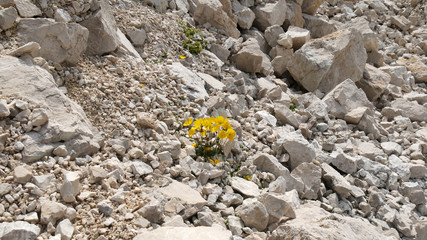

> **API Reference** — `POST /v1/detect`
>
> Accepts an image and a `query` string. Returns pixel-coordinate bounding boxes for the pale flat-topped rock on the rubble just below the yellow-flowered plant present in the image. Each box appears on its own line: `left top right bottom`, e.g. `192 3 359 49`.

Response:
159 181 208 219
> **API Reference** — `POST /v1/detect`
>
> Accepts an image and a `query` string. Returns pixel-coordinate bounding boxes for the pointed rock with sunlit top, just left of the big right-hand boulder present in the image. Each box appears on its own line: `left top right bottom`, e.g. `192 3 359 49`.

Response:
230 38 272 76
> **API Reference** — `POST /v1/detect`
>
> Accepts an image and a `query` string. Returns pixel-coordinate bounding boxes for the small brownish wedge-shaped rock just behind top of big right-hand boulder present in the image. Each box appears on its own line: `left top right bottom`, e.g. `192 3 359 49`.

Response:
302 14 338 38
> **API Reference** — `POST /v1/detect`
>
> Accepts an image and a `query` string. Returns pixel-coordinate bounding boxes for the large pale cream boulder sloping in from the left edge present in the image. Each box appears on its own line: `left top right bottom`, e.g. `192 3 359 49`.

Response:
0 56 101 162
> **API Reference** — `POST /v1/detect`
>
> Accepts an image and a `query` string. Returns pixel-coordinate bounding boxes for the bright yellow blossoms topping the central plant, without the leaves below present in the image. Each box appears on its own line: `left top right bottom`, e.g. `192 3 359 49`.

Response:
184 116 236 142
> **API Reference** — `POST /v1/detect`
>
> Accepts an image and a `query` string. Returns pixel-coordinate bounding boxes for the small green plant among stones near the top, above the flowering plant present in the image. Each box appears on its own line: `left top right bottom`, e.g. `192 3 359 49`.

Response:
180 22 207 55
